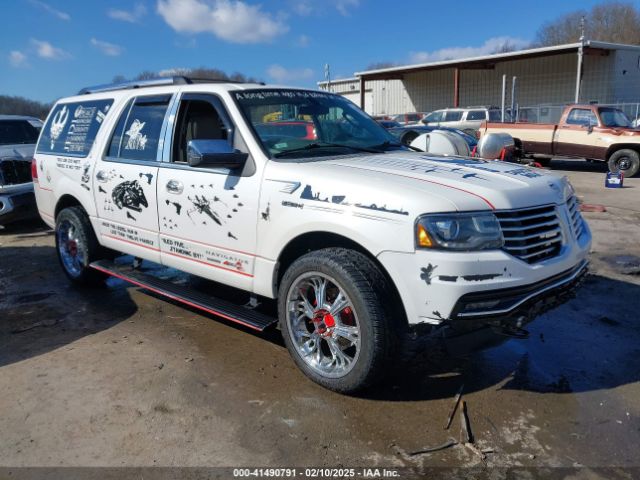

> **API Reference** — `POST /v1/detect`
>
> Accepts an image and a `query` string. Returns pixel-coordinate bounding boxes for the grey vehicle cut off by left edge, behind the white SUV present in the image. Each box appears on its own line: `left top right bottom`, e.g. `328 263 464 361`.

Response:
0 115 42 225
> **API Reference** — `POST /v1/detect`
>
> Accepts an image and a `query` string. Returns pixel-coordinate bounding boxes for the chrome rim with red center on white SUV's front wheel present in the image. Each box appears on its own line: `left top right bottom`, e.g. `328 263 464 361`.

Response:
287 272 360 378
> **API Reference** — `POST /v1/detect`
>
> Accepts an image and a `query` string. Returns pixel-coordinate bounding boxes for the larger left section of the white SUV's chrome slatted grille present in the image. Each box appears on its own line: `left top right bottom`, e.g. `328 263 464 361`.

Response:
496 205 562 263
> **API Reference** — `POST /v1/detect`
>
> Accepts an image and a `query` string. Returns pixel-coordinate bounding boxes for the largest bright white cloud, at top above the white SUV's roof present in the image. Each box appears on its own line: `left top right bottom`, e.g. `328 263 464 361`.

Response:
158 0 289 43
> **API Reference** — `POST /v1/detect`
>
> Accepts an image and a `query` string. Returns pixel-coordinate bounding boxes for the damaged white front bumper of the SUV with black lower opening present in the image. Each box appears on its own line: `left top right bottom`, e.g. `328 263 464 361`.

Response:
378 218 591 325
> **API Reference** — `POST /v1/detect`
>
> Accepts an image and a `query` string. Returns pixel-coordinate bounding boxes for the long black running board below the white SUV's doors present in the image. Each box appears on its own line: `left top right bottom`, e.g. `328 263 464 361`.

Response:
89 260 278 332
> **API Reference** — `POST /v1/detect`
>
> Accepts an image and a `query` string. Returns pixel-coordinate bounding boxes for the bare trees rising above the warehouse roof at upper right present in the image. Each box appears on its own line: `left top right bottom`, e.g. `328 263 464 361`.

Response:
535 1 640 46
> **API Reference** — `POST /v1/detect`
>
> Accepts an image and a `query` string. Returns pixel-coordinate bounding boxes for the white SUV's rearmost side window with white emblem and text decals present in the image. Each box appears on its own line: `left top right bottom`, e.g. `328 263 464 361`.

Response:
37 98 113 157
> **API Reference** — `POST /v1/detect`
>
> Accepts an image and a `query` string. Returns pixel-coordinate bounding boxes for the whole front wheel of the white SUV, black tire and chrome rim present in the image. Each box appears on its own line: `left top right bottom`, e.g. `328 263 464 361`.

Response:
278 248 398 393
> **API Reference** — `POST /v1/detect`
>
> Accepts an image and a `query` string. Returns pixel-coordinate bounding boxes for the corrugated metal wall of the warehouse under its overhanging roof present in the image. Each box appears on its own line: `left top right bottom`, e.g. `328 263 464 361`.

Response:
322 50 640 115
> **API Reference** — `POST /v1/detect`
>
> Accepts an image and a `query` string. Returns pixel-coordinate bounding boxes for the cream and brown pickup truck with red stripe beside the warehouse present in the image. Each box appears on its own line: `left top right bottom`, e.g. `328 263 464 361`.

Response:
480 105 640 177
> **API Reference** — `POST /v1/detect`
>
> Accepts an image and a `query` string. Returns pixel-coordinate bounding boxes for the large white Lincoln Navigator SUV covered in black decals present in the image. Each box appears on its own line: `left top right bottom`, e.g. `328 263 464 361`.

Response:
32 77 591 392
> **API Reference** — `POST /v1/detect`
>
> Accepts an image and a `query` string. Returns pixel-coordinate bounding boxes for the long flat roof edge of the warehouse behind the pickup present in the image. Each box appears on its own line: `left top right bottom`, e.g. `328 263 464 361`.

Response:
350 40 640 79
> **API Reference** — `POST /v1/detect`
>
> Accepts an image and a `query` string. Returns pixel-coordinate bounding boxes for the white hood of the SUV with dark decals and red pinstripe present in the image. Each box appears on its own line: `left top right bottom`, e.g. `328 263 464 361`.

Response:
314 152 571 211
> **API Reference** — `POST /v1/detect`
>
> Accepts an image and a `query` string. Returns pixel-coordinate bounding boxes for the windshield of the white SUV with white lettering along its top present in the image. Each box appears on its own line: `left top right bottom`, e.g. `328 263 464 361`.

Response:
233 89 397 158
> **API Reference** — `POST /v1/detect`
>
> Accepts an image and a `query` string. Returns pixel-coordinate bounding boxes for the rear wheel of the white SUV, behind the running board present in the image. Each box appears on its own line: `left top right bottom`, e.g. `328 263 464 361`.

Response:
55 207 106 286
